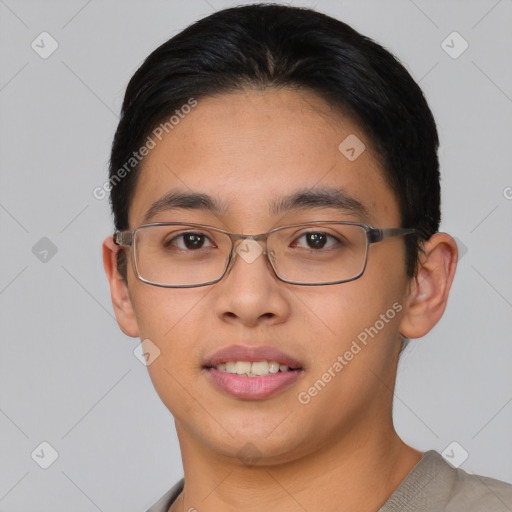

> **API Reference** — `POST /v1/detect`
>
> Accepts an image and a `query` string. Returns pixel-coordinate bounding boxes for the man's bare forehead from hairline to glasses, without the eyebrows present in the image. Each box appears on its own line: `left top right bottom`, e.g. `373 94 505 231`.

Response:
130 89 399 228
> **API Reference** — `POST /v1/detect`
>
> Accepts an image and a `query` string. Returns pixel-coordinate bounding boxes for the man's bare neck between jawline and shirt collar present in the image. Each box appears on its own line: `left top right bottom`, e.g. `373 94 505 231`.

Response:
171 425 422 512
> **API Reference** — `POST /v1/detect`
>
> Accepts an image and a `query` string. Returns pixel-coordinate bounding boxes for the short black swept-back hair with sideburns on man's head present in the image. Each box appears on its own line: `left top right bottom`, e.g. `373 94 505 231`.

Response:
109 4 441 277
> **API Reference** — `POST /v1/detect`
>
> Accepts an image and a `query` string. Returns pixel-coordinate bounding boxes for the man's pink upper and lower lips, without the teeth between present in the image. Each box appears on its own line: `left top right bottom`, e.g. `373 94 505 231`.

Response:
203 345 304 400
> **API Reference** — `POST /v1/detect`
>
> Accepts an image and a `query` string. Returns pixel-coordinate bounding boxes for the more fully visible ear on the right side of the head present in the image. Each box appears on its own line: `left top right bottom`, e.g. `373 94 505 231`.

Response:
400 233 458 338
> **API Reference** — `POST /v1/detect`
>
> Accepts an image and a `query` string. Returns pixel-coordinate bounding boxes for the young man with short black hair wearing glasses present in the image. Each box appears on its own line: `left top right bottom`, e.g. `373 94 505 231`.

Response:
103 5 512 512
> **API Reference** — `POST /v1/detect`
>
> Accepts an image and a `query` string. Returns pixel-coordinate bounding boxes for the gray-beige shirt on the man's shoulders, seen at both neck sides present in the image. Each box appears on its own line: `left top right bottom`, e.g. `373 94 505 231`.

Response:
147 450 512 512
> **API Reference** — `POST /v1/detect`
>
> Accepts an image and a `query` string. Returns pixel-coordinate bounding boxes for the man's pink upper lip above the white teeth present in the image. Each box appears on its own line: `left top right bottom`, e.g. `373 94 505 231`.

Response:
204 345 302 368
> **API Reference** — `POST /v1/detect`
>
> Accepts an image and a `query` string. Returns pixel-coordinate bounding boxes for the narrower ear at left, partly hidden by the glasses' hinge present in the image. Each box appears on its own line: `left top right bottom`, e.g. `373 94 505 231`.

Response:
103 236 139 338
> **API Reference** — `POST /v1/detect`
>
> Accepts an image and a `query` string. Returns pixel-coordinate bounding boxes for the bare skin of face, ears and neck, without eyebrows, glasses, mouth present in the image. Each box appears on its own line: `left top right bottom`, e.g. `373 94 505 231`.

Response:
103 89 457 512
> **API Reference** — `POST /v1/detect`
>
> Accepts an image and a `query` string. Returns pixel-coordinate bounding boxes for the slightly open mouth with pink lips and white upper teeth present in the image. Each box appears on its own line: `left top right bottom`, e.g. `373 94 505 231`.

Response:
203 345 304 400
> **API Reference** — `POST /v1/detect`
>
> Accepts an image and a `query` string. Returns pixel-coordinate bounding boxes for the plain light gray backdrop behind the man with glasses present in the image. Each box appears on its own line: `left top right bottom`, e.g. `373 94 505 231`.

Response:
0 0 512 512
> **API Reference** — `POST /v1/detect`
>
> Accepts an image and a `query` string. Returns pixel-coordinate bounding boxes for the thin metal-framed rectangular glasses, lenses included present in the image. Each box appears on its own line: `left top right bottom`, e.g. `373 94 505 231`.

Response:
114 221 417 288
